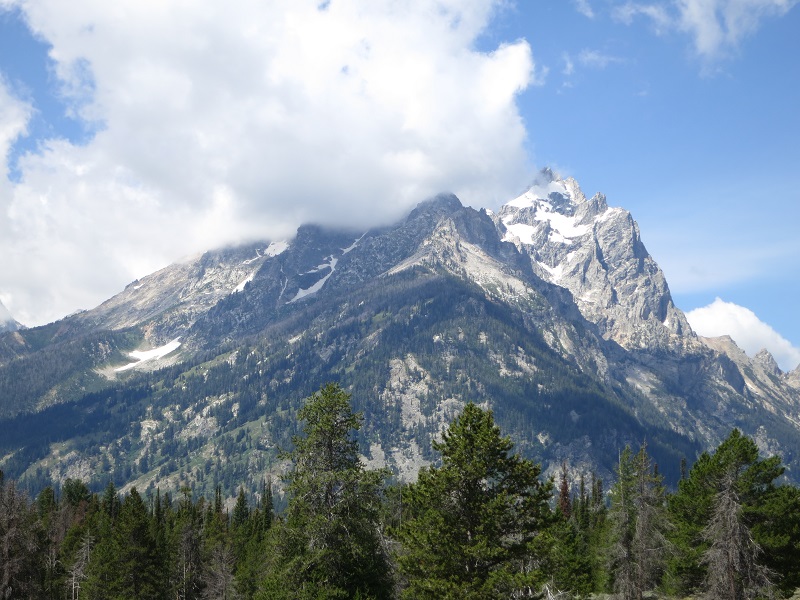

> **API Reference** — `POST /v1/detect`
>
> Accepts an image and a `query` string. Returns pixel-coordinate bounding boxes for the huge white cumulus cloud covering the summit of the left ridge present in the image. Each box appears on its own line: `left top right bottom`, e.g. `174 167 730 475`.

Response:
0 0 536 325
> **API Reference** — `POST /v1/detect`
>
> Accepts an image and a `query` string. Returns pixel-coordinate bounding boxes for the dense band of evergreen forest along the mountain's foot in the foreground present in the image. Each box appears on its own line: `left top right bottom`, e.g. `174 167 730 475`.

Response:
0 384 800 600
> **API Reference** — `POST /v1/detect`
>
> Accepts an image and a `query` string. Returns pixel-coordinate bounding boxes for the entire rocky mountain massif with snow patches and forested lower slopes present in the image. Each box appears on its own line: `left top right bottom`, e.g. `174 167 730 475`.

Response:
0 170 800 494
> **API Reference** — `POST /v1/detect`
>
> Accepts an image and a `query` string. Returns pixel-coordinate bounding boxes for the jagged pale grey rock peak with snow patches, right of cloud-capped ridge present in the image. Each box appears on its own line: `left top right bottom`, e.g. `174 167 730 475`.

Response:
496 170 692 349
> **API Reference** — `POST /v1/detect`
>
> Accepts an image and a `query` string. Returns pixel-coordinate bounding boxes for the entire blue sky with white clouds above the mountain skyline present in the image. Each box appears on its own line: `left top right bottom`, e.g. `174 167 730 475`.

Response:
0 0 800 370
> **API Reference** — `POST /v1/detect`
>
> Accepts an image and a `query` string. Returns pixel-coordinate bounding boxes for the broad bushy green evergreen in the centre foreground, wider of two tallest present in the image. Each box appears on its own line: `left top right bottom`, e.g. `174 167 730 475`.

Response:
398 403 552 599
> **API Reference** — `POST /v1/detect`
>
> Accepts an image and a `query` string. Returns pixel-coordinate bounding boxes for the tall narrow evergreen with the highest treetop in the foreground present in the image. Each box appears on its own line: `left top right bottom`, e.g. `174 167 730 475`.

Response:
264 384 392 598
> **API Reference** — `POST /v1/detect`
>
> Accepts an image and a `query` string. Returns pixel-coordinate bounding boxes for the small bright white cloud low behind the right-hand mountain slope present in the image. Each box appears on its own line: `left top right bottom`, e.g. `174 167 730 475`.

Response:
686 298 800 371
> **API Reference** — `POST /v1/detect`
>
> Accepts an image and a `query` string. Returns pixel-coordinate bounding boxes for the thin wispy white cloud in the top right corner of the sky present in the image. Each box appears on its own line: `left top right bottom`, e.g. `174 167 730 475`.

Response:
613 0 798 61
